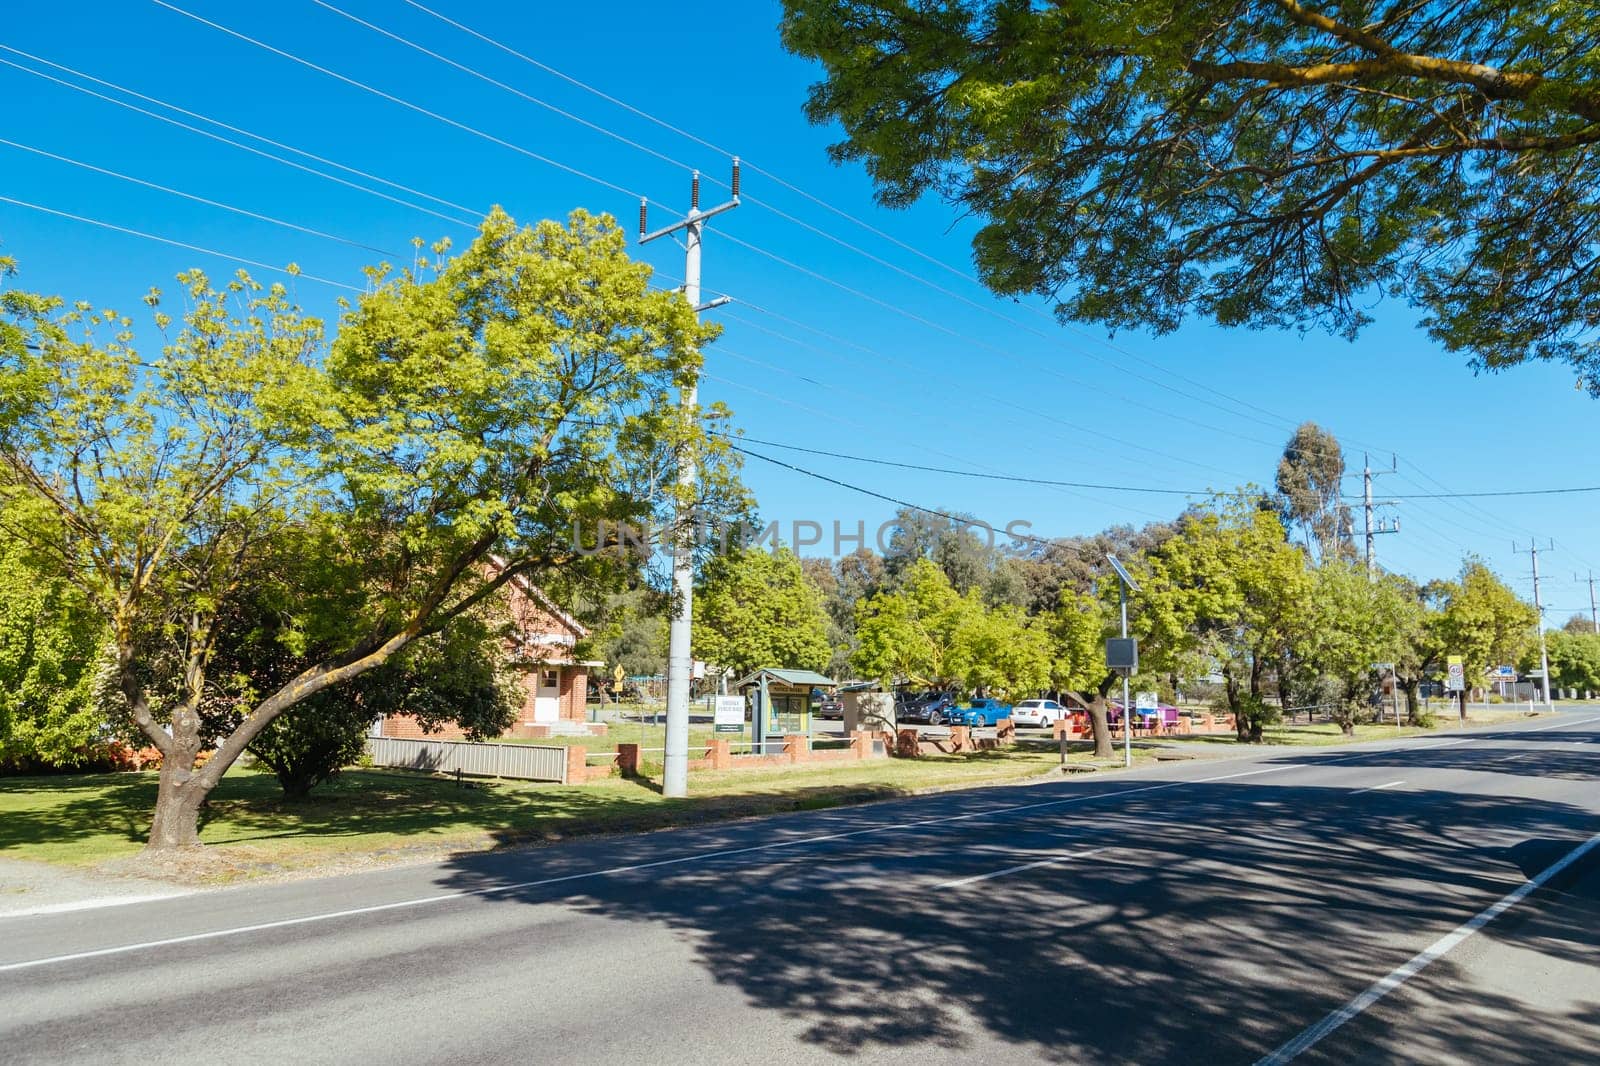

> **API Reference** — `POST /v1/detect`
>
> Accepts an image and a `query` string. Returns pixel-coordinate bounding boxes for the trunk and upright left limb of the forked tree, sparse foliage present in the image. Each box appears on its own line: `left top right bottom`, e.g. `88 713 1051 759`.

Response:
0 264 322 845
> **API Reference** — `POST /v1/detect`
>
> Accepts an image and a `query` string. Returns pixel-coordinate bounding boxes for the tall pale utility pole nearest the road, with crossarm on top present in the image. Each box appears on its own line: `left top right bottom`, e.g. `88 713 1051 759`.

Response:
638 157 739 797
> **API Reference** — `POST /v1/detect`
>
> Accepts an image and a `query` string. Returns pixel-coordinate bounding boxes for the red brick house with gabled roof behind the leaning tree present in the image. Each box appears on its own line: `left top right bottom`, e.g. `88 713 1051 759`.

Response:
374 563 603 739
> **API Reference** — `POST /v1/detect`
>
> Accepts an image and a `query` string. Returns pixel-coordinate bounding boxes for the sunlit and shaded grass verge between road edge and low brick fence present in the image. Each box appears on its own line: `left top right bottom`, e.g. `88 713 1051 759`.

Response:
0 751 1054 880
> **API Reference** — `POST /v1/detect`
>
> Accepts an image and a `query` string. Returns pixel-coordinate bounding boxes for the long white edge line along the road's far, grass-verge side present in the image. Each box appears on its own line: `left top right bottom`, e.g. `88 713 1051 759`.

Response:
0 715 1600 973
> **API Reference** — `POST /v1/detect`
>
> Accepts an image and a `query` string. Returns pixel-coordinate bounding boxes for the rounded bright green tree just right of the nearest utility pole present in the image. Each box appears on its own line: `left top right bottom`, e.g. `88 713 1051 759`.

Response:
693 547 834 674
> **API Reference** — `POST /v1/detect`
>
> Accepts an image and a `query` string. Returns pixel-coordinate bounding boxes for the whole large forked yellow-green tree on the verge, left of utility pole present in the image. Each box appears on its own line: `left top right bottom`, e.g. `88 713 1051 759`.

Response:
0 211 742 848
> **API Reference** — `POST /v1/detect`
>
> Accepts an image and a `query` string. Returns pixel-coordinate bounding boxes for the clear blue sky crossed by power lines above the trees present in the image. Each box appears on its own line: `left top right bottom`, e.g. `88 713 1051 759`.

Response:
0 0 1600 623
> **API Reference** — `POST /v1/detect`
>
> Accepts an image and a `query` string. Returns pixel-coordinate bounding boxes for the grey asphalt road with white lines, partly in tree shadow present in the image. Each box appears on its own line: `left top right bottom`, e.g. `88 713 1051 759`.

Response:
0 712 1600 1064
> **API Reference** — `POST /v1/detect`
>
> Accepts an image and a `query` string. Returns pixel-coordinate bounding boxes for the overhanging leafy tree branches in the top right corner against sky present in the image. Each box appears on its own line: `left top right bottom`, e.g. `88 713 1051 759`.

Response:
782 0 1600 395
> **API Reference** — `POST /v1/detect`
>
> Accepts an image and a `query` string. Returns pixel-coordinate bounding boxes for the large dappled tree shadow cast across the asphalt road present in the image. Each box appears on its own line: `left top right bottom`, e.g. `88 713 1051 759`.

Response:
432 752 1600 1063
